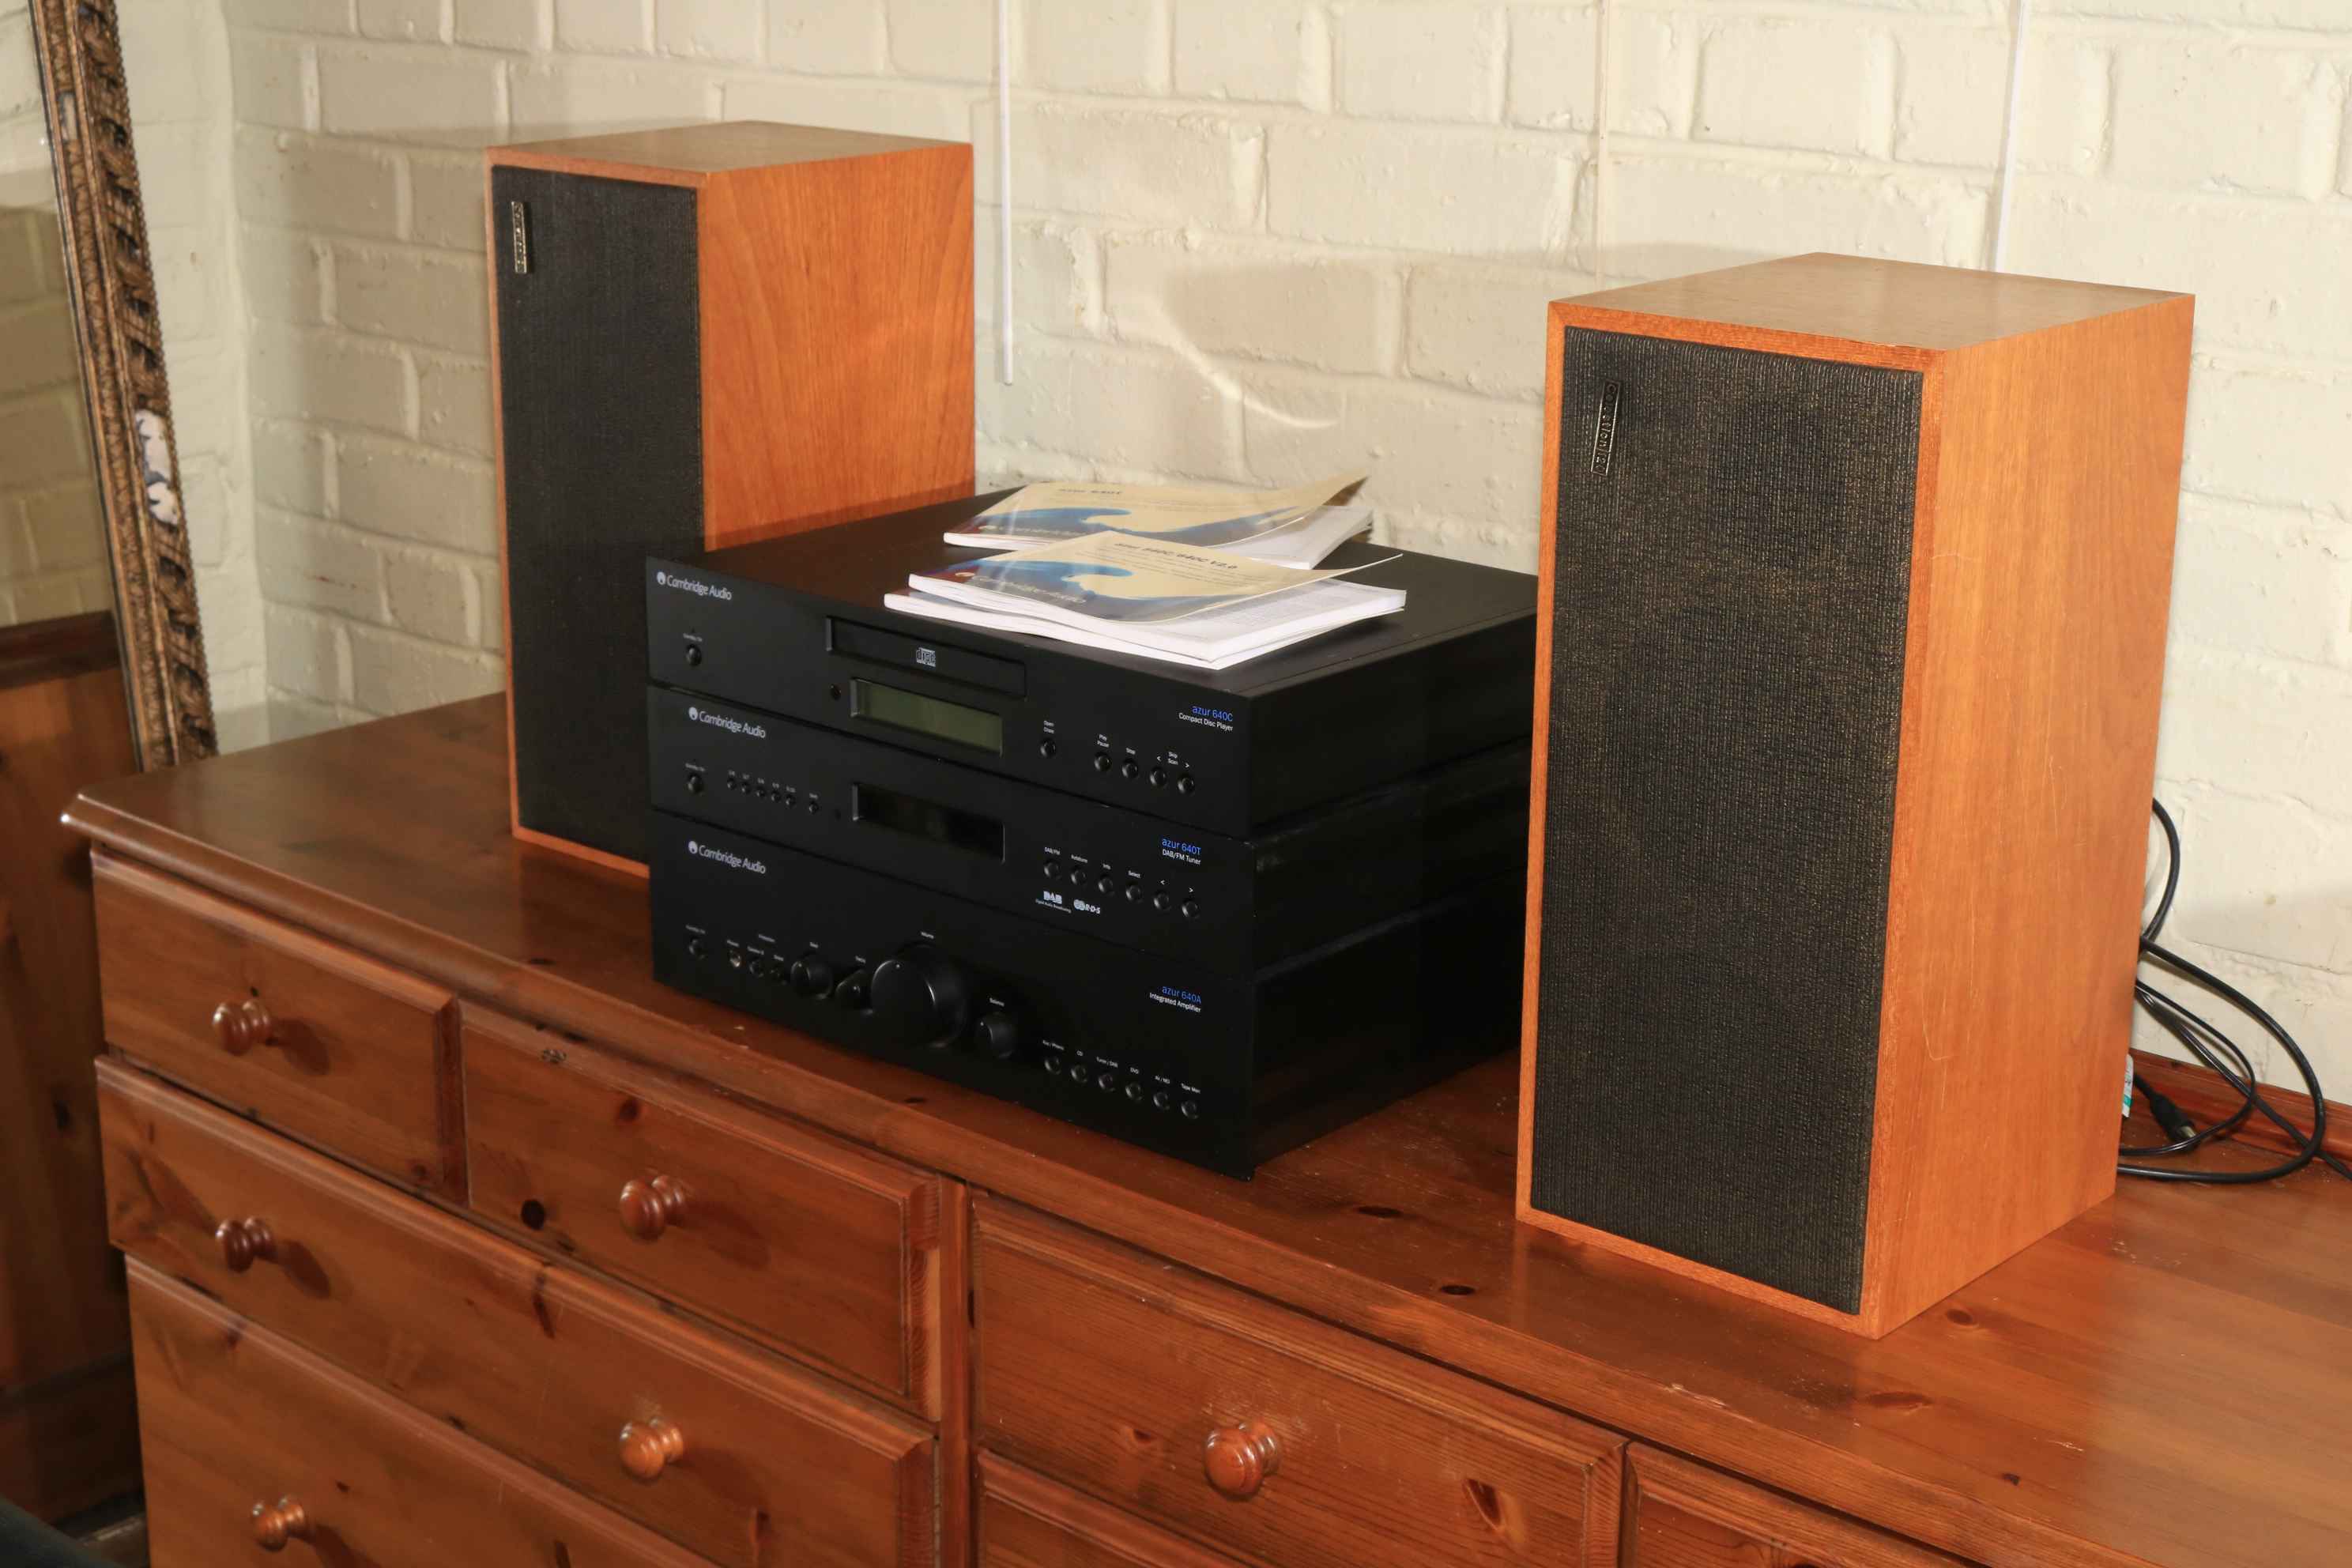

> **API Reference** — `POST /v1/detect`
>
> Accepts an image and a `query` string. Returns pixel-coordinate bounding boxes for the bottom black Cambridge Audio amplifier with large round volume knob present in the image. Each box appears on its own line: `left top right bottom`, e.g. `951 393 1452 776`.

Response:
651 813 1519 1175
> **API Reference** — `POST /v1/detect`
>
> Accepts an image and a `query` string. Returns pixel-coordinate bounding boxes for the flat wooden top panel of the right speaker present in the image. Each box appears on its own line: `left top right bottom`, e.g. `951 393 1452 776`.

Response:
1552 254 2183 369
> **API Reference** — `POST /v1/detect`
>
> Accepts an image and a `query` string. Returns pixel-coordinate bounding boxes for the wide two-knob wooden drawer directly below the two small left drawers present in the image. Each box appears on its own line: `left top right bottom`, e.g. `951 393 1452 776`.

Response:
99 1062 936 1568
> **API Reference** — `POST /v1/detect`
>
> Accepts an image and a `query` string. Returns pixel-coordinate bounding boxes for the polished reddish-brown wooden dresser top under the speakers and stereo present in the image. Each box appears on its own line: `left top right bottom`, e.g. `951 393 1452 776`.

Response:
68 698 2352 1568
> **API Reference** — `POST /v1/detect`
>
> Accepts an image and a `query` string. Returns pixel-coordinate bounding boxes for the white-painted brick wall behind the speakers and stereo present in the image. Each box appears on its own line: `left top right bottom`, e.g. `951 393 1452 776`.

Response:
105 0 2352 1098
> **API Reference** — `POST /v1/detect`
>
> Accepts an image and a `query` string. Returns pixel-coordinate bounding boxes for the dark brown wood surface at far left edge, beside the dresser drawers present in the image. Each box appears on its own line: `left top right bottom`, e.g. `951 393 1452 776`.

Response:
0 644 139 1519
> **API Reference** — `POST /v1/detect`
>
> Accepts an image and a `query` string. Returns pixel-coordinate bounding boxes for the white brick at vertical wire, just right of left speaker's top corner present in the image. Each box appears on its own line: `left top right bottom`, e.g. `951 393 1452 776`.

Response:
974 106 1263 228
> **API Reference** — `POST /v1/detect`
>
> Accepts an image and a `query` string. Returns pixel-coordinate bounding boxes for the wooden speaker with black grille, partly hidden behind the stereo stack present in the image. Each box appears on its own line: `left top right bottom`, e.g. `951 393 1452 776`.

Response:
487 122 971 870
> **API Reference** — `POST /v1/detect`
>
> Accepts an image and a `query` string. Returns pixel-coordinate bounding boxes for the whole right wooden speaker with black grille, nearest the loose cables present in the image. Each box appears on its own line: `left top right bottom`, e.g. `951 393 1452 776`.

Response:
1519 256 2192 1336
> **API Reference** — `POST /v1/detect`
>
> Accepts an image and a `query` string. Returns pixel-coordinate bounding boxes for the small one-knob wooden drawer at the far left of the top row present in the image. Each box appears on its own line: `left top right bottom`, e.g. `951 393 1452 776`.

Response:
92 854 463 1197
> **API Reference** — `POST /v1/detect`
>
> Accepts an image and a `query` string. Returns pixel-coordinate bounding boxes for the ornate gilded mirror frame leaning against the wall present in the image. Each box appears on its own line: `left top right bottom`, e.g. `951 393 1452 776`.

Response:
31 0 219 769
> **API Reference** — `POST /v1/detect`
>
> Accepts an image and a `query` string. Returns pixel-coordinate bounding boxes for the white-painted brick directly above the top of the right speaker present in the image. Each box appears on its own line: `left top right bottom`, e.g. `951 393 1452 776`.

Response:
1604 155 1990 277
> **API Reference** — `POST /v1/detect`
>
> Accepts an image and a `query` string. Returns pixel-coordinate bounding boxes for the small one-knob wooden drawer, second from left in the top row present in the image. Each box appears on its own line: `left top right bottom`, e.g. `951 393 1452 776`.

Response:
466 1008 955 1418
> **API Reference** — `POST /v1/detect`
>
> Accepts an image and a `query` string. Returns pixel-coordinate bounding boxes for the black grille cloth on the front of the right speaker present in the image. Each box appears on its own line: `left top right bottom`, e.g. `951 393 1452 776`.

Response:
1531 329 1919 1312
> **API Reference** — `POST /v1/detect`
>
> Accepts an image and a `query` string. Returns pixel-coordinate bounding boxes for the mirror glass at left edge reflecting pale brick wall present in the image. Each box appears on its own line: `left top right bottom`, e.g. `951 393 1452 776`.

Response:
0 7 115 625
